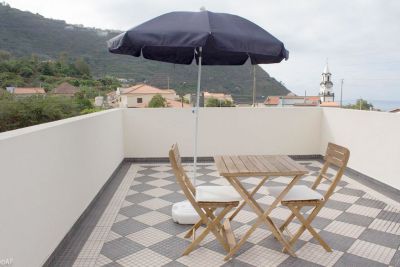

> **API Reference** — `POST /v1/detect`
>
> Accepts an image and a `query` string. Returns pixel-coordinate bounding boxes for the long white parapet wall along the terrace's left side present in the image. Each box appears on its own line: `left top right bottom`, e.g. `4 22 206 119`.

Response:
0 109 124 267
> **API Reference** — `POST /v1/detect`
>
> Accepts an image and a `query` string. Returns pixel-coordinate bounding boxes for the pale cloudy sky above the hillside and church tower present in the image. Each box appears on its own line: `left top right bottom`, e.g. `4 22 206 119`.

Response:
6 0 400 102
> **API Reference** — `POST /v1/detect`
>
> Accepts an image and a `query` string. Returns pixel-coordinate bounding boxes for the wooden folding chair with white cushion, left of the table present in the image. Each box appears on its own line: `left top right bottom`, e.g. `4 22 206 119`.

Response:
169 144 241 255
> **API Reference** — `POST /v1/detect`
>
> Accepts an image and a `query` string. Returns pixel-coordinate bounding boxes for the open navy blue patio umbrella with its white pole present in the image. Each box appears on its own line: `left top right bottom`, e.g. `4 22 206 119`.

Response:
108 11 289 182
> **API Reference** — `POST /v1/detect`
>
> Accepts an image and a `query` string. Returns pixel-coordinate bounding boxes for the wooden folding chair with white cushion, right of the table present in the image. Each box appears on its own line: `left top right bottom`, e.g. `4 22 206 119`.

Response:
269 143 350 252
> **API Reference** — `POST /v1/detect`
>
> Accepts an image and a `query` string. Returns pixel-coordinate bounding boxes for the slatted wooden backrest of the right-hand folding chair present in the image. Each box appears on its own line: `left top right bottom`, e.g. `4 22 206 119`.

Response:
312 143 350 201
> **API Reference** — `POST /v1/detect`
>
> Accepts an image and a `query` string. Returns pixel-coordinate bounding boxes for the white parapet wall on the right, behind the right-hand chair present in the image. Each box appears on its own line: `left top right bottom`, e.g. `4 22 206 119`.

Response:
320 108 400 190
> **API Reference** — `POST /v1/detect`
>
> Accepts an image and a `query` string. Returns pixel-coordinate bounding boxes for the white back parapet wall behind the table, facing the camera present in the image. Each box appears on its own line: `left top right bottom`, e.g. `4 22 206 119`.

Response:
124 108 322 158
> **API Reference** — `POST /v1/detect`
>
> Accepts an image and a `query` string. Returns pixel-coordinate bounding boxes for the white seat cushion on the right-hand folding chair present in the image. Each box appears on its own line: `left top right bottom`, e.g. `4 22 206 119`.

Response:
268 185 324 201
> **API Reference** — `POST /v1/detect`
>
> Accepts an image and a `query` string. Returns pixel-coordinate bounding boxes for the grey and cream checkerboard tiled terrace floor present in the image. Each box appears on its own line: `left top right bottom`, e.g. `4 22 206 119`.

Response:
52 161 400 267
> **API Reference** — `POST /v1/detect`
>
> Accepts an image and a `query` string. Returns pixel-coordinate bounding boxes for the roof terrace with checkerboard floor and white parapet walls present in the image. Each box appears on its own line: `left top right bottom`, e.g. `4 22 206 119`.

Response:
0 107 400 266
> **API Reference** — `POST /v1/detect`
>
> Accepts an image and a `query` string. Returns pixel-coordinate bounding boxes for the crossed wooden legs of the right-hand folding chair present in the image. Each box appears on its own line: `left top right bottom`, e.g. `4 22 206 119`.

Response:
288 205 332 252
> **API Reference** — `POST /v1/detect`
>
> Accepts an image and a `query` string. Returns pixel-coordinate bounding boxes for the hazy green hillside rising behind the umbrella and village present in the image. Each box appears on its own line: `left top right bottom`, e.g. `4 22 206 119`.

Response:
0 4 289 102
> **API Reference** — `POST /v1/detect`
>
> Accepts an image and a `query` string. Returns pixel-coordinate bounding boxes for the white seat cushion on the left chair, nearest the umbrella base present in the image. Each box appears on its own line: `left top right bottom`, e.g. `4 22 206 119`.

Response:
196 185 242 202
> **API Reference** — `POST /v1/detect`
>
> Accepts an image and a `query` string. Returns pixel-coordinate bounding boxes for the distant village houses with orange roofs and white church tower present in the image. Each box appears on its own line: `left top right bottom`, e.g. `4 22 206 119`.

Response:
7 64 400 113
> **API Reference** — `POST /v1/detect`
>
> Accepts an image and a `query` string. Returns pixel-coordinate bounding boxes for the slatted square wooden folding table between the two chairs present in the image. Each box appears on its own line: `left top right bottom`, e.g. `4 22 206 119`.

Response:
214 155 308 260
